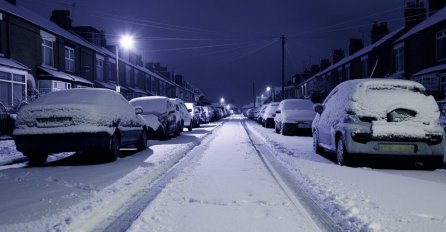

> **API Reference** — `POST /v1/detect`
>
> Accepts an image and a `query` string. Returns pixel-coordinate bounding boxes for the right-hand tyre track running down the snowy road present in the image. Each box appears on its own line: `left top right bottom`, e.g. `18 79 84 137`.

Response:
241 119 342 232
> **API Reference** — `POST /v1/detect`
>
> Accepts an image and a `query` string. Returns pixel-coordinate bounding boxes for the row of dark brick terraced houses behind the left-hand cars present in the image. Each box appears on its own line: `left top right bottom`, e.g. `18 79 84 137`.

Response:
0 0 199 137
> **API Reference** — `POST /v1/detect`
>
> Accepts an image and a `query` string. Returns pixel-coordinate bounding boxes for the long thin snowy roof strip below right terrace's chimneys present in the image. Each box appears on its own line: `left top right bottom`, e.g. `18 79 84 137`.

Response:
308 27 404 80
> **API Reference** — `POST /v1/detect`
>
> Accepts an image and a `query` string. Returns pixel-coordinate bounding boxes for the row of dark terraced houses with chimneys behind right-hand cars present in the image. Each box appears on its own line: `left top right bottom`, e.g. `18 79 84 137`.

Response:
286 0 446 100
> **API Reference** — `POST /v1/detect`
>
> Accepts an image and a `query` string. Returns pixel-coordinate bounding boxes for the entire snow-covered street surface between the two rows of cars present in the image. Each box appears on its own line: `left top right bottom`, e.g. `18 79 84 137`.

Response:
0 117 446 231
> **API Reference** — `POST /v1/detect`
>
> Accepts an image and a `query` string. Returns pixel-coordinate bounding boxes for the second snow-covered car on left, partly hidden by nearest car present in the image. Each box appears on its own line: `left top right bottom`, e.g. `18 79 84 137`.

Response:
130 96 183 140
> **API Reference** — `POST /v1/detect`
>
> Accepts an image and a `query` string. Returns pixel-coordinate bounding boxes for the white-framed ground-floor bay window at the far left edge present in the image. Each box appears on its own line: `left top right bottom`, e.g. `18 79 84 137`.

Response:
0 70 26 107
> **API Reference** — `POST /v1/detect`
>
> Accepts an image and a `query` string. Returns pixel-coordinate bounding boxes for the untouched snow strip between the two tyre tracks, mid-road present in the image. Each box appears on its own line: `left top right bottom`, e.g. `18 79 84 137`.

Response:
129 120 318 232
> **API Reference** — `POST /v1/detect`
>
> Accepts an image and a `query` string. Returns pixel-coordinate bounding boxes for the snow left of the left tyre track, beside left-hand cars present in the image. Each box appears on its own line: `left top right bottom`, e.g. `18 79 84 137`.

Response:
0 123 219 231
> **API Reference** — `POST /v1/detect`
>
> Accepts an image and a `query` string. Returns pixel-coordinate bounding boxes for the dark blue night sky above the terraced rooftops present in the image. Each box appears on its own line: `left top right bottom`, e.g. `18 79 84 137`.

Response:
17 0 404 106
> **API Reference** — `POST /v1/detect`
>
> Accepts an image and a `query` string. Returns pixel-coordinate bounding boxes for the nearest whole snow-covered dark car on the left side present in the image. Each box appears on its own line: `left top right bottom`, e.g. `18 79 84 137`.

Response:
13 88 147 165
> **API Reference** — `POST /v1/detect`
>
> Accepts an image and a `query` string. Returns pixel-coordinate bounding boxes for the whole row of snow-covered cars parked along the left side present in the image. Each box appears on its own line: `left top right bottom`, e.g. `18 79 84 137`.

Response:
13 88 225 166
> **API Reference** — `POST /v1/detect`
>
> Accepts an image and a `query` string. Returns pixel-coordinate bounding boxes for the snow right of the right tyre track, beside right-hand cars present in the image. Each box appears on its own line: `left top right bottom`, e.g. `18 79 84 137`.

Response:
248 118 446 231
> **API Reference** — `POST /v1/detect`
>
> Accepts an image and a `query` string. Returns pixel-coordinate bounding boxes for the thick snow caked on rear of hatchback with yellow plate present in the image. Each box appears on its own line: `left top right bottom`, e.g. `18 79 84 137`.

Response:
346 80 443 138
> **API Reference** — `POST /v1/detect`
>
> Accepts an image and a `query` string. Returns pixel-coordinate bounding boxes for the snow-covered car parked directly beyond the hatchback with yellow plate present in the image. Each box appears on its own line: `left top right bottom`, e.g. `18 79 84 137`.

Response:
274 99 316 135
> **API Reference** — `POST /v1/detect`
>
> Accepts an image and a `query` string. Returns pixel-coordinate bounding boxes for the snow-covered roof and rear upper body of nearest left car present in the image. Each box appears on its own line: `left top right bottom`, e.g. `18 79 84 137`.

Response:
14 89 142 135
